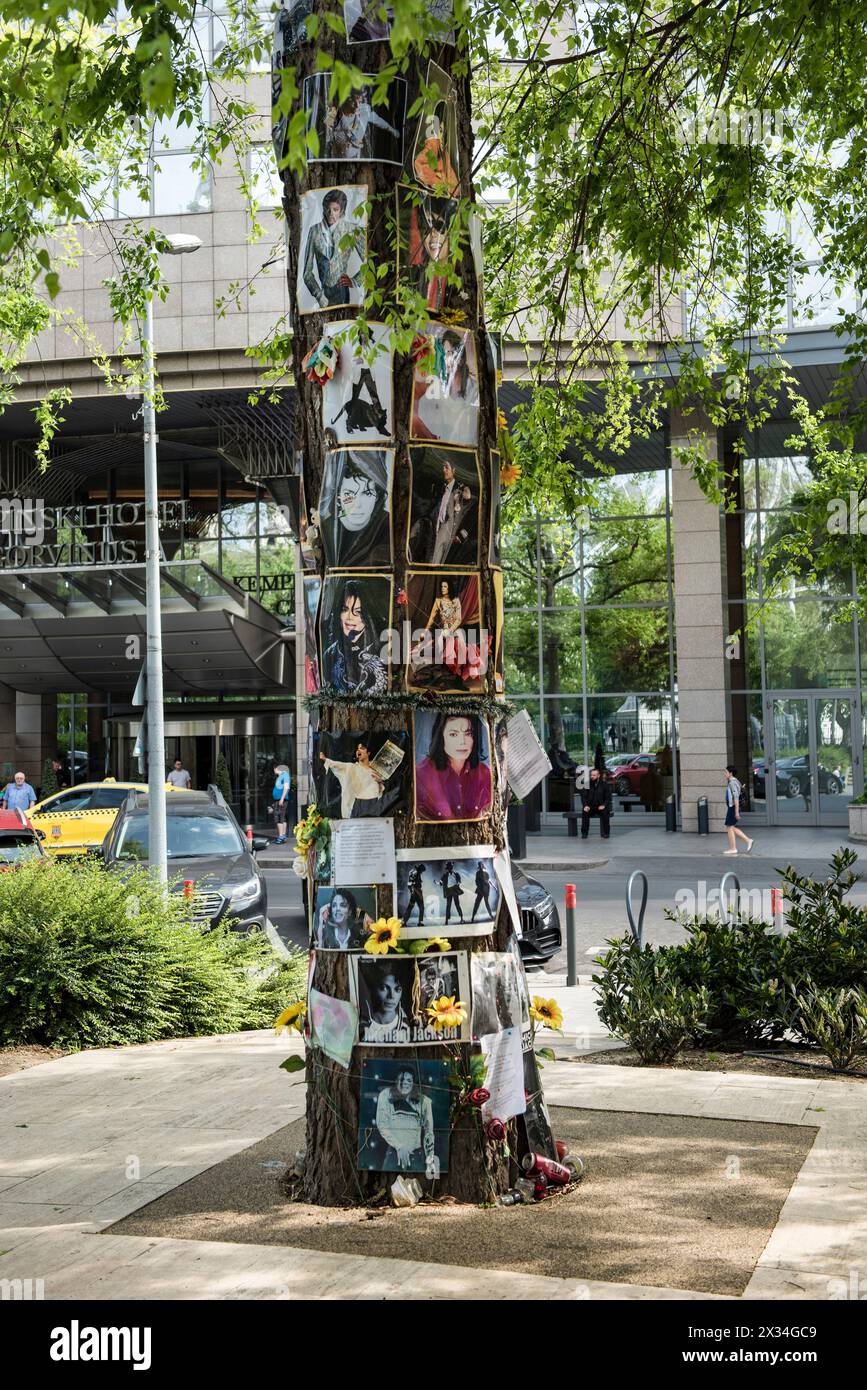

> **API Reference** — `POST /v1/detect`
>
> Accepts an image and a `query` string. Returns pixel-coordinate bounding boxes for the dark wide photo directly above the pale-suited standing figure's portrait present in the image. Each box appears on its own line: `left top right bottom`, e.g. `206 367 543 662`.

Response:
304 72 406 165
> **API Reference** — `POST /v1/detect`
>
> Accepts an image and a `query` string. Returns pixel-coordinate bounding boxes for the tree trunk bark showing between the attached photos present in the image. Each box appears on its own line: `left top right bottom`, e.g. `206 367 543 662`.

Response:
277 8 544 1205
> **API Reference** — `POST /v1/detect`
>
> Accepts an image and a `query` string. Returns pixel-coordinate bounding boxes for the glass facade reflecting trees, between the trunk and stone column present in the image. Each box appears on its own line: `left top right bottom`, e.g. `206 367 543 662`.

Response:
503 470 677 813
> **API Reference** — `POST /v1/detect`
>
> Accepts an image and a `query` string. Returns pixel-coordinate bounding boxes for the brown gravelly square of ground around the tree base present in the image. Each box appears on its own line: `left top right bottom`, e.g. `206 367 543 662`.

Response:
110 1108 816 1295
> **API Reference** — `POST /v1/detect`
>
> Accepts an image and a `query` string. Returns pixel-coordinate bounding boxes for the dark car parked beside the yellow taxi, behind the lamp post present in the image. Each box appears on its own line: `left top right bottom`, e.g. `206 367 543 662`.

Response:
101 787 270 931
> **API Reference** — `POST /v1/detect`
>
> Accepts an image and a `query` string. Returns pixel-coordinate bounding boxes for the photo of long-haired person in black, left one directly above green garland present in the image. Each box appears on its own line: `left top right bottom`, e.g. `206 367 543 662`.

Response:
320 573 392 695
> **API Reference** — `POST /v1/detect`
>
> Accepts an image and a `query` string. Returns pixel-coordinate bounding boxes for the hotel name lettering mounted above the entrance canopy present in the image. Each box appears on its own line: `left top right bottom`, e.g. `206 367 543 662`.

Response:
0 498 186 570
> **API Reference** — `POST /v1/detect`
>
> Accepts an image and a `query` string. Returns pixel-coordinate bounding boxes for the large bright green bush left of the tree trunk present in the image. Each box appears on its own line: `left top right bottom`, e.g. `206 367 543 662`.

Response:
0 860 306 1048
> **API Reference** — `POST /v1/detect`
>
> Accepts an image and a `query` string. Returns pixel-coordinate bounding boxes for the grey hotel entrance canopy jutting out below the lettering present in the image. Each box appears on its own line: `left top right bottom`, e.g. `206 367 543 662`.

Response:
0 560 295 696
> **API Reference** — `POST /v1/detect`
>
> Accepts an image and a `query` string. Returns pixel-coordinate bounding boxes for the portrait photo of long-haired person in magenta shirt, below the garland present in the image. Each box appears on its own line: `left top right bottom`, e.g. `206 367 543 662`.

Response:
413 709 493 823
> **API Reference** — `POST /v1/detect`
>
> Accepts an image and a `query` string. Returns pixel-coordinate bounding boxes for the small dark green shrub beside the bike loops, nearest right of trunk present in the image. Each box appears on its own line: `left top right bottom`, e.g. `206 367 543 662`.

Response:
593 937 710 1065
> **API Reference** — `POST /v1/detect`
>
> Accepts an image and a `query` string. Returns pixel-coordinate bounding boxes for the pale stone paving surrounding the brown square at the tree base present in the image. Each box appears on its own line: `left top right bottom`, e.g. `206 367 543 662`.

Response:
0 995 867 1301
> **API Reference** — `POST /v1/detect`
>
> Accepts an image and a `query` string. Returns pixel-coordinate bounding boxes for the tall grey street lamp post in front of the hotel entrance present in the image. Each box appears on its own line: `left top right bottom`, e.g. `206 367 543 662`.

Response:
142 227 201 883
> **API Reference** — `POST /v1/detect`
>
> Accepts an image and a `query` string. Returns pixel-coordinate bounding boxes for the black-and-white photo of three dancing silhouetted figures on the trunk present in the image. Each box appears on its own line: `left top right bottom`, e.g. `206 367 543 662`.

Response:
396 845 500 941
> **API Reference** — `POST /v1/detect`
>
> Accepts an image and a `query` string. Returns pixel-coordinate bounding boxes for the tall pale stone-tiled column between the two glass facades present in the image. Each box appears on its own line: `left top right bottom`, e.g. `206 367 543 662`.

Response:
671 413 731 833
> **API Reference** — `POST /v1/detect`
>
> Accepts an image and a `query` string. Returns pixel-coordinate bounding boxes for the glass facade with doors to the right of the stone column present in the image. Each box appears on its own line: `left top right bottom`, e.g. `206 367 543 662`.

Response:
725 449 863 824
